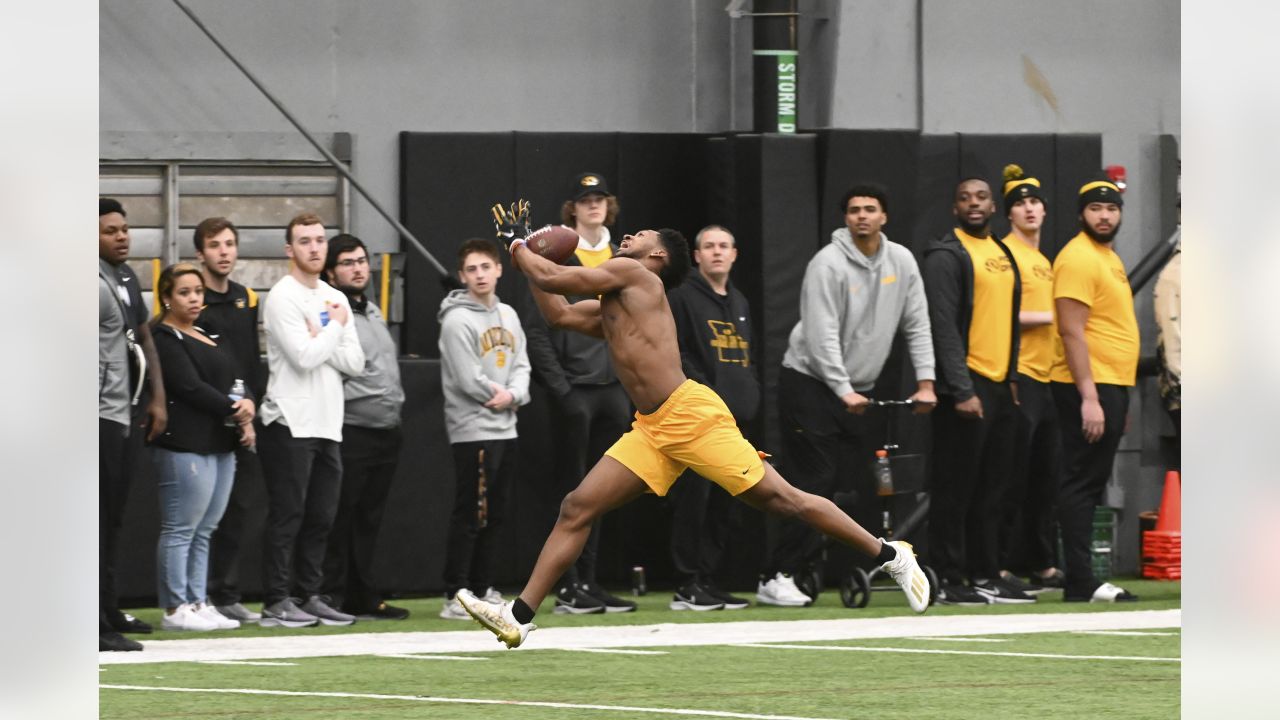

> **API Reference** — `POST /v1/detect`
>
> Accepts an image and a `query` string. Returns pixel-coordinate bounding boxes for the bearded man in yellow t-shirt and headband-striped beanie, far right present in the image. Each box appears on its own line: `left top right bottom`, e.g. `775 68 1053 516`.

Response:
1050 179 1138 602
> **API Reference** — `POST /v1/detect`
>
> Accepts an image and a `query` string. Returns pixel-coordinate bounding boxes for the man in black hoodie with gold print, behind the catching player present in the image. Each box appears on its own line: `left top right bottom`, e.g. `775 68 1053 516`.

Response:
667 225 760 610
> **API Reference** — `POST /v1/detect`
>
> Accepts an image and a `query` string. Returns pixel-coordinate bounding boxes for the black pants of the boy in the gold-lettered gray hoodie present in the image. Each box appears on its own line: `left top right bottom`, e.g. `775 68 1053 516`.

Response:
444 439 518 597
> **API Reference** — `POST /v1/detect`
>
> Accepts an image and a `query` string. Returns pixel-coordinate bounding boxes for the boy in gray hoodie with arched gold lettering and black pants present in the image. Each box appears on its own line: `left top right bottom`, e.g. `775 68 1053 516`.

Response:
436 238 530 620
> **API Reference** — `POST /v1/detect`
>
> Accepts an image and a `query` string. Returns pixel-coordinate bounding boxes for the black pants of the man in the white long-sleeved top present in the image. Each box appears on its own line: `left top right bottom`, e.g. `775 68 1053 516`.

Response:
257 423 342 605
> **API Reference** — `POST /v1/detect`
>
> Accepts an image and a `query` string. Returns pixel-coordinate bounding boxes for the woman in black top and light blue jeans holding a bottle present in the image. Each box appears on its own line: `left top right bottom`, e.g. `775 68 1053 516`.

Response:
151 263 255 630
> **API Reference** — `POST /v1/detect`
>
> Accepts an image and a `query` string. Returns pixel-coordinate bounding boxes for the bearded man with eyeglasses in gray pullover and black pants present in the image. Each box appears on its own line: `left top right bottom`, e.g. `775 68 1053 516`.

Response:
324 233 408 620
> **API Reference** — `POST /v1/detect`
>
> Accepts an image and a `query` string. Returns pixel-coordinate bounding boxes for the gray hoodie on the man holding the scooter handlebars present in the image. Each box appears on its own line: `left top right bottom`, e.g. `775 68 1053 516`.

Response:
782 228 933 396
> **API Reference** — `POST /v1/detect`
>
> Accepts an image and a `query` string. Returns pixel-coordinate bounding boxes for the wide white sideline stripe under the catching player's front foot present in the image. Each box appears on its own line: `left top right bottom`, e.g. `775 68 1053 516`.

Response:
97 609 1183 665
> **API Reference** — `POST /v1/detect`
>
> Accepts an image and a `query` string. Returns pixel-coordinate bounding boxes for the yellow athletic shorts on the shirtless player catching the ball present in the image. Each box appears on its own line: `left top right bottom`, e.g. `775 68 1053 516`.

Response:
605 380 764 496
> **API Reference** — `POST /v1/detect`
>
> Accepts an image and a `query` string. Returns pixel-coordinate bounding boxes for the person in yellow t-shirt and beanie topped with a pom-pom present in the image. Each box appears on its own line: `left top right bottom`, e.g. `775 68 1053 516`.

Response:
1000 165 1062 594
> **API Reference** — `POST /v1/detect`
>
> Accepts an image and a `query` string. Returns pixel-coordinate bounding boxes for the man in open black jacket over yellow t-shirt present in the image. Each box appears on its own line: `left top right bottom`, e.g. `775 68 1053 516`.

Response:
922 178 1036 605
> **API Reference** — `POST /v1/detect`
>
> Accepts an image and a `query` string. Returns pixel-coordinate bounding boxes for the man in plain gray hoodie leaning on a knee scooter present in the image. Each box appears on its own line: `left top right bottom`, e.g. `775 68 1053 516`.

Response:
756 184 937 606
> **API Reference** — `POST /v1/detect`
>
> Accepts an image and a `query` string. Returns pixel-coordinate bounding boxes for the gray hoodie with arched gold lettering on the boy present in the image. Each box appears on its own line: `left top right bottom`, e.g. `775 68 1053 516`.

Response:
436 290 529 443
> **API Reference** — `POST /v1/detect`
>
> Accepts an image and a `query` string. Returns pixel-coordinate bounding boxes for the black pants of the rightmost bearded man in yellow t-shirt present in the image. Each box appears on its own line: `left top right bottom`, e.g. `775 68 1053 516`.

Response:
1051 383 1129 598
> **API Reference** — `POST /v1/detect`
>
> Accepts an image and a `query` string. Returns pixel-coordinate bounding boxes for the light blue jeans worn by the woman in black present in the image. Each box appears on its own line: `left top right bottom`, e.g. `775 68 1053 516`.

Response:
151 447 236 607
